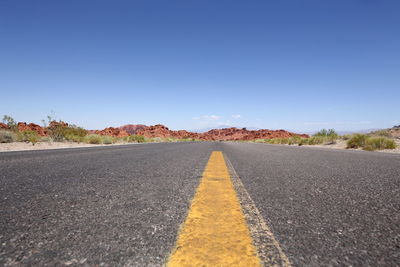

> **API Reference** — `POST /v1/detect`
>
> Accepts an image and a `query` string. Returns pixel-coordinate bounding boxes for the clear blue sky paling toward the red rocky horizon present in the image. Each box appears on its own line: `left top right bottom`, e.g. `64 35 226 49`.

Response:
0 0 400 131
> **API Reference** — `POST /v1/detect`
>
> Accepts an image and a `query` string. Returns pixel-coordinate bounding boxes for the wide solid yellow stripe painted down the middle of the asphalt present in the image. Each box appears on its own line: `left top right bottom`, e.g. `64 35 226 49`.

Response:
168 151 261 266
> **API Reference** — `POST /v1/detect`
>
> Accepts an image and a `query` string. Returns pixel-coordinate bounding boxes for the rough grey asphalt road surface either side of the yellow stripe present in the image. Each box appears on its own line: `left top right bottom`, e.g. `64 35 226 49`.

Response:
0 142 400 266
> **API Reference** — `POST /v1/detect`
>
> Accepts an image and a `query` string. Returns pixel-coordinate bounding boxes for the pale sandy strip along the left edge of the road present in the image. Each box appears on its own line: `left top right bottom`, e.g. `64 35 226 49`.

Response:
0 142 135 152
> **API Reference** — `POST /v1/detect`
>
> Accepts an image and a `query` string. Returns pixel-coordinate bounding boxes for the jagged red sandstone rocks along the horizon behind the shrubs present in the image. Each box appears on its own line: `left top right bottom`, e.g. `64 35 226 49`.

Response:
0 121 309 141
